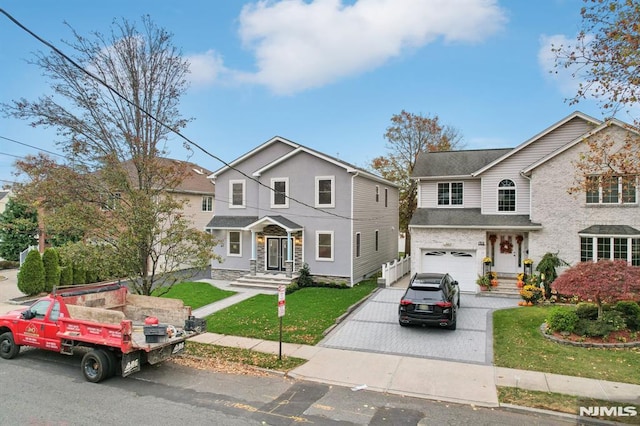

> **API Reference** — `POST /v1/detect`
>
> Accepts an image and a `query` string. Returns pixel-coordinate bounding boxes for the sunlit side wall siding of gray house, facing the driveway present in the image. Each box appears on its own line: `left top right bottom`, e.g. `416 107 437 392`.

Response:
352 176 398 282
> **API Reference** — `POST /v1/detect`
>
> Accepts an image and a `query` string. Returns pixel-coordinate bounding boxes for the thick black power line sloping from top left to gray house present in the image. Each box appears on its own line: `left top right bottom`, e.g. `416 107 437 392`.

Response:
0 8 376 220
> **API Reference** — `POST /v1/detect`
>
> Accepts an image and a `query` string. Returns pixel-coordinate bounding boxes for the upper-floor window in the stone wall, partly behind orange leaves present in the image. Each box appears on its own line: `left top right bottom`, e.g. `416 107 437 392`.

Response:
585 176 637 204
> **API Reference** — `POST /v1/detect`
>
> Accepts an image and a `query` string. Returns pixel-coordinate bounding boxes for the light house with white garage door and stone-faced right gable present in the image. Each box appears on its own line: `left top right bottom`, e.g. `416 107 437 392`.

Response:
409 112 640 292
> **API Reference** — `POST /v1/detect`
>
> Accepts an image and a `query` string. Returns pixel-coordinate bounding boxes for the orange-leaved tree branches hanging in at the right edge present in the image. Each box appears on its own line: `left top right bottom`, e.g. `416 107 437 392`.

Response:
552 0 640 192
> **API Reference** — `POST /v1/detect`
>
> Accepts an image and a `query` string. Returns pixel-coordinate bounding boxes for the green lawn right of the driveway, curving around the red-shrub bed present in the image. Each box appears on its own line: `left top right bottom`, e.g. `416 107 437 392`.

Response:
493 306 640 384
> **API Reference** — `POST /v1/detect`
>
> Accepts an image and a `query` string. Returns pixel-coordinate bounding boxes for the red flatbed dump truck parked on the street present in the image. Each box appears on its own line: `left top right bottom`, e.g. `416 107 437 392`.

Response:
0 283 205 383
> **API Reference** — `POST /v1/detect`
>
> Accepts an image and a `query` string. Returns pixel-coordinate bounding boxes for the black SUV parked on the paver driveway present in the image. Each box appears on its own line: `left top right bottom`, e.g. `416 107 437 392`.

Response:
398 273 460 330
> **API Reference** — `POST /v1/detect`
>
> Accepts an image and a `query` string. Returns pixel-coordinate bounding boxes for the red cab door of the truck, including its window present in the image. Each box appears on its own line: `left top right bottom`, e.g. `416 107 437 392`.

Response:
17 300 60 350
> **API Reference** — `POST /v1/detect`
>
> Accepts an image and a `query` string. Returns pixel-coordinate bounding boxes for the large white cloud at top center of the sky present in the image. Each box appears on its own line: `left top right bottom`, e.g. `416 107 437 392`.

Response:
230 0 506 94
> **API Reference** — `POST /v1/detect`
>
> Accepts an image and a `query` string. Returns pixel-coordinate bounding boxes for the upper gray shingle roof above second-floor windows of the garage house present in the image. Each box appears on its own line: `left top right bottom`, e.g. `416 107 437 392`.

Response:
411 148 513 178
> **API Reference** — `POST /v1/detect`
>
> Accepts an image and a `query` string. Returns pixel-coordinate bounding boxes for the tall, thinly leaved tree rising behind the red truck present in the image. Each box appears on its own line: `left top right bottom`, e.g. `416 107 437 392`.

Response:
2 16 220 294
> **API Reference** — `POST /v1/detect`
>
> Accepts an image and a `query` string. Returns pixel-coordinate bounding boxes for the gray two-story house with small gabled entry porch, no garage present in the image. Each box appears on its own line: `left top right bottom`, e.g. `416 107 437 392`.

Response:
206 137 398 285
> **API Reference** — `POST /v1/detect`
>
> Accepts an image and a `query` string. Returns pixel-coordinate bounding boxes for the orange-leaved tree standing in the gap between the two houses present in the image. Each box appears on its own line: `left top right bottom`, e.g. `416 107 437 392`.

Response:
370 110 462 254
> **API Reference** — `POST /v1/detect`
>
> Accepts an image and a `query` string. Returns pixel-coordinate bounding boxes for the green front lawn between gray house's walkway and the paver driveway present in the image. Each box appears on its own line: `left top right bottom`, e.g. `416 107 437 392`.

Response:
207 279 377 345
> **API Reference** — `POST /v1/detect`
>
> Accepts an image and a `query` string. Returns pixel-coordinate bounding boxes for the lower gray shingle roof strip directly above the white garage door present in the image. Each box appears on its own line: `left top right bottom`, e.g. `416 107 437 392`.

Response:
410 209 542 229
